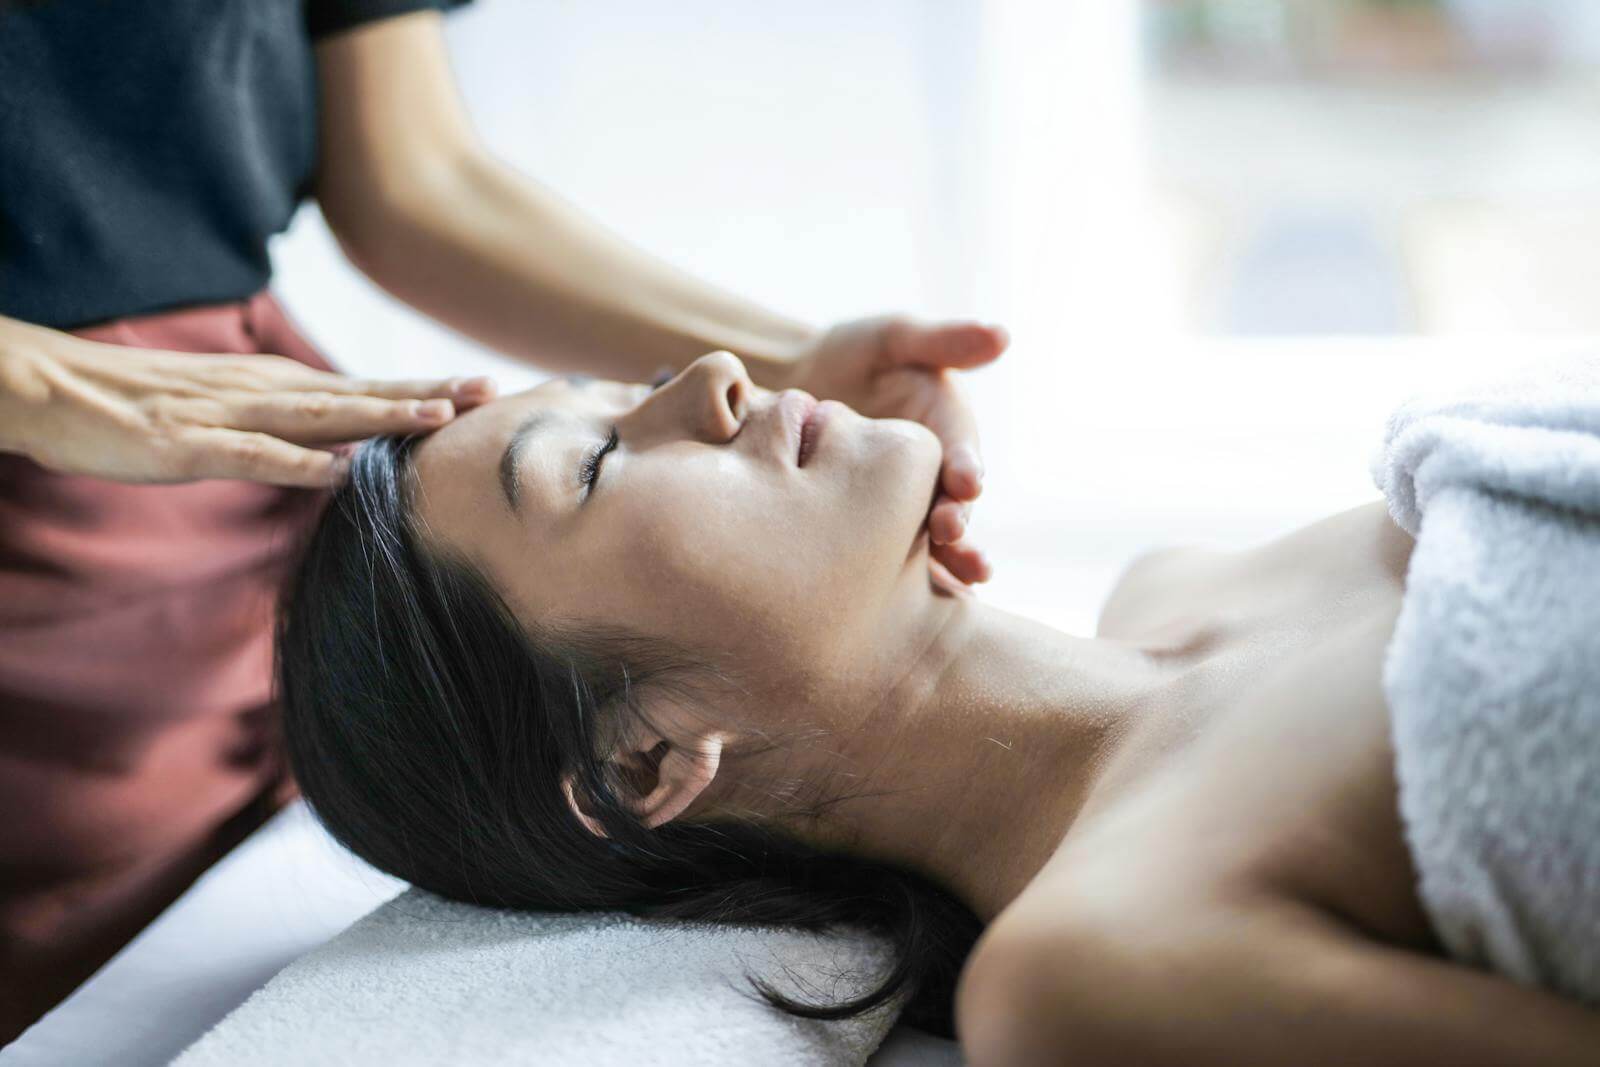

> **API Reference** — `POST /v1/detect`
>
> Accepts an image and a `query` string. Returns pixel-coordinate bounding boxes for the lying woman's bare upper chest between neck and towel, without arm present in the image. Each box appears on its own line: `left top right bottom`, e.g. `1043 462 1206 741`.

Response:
1030 507 1432 947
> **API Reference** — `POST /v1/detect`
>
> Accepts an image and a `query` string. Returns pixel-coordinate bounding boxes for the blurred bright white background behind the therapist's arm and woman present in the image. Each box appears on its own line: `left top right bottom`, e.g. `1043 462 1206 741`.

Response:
275 0 1600 633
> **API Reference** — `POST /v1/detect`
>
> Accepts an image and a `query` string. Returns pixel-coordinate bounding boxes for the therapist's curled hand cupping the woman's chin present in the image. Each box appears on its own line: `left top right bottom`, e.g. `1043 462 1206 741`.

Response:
787 315 1010 584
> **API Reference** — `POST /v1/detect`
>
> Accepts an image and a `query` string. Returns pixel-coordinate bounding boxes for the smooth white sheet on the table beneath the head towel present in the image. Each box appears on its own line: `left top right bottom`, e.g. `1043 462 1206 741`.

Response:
0 803 963 1067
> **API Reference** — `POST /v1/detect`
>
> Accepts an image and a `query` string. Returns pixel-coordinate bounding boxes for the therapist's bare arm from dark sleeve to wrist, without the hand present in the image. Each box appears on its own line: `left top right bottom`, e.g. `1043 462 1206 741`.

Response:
317 13 819 386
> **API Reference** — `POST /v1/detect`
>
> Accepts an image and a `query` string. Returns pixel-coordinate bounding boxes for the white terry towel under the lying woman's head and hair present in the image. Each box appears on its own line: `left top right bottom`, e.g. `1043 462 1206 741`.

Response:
173 889 898 1067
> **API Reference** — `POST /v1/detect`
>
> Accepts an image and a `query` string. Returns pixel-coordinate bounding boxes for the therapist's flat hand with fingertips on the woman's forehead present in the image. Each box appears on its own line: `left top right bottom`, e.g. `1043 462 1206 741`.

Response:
0 322 494 488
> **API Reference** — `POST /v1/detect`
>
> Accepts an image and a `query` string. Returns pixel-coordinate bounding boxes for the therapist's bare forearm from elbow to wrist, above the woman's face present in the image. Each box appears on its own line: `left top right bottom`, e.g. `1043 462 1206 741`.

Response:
320 152 816 387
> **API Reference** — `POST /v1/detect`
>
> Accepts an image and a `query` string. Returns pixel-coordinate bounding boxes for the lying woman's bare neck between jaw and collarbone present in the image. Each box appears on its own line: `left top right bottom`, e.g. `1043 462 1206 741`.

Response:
808 597 1174 923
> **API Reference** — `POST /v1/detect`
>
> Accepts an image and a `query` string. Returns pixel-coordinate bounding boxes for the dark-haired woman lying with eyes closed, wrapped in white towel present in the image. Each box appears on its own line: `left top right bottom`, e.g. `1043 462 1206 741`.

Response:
278 352 1600 1067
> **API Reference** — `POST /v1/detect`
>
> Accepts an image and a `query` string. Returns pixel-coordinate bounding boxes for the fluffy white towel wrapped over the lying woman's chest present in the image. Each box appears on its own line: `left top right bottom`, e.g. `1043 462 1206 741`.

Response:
1373 355 1600 1003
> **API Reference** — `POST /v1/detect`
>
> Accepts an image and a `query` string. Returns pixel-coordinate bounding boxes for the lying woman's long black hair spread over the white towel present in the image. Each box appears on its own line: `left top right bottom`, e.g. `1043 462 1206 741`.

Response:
275 435 981 1037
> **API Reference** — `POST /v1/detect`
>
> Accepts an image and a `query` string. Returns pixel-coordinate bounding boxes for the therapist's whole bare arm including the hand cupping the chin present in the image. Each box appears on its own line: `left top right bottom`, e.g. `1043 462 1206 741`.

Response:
315 11 1008 584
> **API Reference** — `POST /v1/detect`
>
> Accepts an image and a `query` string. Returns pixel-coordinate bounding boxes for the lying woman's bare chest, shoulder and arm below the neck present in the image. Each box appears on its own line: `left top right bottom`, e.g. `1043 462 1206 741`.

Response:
957 504 1600 1067
